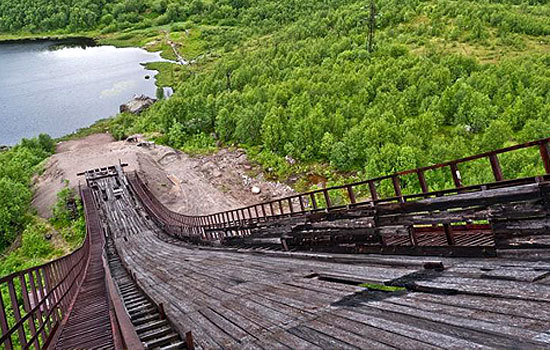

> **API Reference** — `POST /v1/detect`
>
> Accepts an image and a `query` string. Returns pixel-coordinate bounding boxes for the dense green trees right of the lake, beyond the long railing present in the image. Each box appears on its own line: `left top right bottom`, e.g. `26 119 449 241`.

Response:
109 0 550 189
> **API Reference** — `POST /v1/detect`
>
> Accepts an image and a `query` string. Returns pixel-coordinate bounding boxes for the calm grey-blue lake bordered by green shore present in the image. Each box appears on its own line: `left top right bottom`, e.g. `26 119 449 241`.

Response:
0 40 163 145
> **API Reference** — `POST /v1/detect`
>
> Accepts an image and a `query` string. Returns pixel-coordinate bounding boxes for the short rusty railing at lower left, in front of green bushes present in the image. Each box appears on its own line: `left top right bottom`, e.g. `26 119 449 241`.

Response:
0 190 93 350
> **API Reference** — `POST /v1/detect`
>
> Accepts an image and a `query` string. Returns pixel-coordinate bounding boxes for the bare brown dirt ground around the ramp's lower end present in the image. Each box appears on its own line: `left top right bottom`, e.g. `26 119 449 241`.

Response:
33 134 293 217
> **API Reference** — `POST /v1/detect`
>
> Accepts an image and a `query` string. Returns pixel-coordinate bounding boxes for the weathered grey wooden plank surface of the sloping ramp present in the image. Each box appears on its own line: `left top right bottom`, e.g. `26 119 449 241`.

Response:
97 178 550 349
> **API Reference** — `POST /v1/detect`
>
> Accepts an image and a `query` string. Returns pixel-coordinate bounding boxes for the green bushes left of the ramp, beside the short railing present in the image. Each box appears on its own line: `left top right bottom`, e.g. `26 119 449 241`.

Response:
0 134 85 278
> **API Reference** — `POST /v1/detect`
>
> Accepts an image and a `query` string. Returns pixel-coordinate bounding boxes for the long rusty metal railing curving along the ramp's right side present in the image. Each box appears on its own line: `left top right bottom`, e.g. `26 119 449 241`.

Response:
130 138 550 240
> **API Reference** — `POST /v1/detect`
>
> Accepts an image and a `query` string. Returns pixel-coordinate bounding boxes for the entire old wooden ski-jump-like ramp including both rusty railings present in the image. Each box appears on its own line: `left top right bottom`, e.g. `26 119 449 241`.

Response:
0 139 550 350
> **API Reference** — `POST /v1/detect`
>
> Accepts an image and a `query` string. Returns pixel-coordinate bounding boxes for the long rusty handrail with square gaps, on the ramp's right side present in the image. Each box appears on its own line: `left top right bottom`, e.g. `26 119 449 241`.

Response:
131 138 550 239
